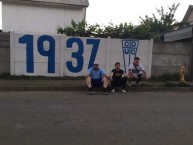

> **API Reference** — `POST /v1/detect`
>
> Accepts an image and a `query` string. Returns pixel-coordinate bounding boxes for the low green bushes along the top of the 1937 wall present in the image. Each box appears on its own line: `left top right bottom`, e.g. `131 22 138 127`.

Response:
57 21 151 39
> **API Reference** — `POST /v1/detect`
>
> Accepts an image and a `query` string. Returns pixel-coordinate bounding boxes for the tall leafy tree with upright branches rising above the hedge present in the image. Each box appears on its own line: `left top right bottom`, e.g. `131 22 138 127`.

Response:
136 3 180 39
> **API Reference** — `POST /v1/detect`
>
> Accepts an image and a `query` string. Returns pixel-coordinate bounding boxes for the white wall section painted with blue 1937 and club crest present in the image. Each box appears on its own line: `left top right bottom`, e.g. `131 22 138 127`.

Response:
10 33 153 76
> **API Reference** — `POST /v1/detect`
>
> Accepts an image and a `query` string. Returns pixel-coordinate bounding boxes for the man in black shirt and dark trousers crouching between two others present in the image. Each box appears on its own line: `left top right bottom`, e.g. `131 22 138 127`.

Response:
111 62 127 93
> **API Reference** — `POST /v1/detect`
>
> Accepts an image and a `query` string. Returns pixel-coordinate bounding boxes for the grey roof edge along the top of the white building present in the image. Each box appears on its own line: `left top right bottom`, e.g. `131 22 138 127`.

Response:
0 0 89 7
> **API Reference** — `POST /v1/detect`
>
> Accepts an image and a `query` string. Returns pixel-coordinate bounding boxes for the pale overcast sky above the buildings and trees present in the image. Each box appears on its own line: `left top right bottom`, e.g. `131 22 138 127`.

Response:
0 0 193 29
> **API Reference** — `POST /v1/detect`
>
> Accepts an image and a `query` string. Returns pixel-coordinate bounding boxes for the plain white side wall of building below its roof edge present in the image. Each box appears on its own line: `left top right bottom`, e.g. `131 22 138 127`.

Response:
2 2 85 34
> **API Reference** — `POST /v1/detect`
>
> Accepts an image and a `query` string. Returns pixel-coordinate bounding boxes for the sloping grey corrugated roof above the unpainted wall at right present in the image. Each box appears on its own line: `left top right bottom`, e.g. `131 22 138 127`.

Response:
164 26 193 42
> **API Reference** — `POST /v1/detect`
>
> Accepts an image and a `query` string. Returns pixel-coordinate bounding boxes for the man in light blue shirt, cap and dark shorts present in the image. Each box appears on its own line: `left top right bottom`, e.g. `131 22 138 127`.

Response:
85 61 109 95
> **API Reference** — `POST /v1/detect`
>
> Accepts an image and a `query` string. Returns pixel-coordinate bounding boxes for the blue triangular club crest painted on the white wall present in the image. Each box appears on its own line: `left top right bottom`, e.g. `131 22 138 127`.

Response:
122 39 139 72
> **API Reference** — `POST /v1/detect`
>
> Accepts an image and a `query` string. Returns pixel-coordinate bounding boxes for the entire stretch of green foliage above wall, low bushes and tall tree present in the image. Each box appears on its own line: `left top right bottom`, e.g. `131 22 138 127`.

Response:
57 3 180 39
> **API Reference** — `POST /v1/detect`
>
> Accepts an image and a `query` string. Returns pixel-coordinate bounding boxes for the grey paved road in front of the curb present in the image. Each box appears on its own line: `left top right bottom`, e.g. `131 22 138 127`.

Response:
0 92 193 145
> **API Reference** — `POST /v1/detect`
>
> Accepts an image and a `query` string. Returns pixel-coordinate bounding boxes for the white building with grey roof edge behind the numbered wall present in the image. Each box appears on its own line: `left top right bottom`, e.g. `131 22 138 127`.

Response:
0 0 89 33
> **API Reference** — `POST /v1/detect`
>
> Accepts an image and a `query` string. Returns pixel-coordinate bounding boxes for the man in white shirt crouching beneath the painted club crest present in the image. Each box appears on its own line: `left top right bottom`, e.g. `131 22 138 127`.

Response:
128 57 147 85
